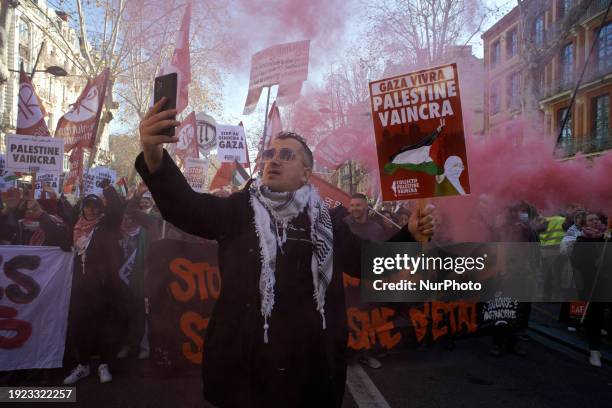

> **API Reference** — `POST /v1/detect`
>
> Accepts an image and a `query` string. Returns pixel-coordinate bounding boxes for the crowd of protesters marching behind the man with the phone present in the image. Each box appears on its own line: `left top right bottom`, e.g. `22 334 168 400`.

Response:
0 178 609 392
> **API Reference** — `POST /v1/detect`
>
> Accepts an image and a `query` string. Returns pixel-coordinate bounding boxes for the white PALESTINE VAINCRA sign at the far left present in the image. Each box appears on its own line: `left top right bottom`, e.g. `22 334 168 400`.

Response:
6 134 64 174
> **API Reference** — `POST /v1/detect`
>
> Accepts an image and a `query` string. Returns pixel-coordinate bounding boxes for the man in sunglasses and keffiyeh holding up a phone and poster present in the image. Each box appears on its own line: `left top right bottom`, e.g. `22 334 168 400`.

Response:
136 100 433 408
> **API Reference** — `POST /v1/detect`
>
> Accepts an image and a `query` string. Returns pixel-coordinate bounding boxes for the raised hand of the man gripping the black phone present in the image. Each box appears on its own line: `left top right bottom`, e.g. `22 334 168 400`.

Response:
139 97 181 173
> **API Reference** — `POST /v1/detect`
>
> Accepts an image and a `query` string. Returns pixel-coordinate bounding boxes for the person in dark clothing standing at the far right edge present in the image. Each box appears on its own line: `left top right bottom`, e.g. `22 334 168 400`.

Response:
571 212 612 367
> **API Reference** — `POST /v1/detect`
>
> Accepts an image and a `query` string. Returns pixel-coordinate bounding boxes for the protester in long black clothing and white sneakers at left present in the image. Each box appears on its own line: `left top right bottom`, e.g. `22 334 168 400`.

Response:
64 180 127 384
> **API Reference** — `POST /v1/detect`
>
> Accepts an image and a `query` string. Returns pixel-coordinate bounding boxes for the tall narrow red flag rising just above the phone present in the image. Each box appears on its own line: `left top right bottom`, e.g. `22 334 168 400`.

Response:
164 2 191 113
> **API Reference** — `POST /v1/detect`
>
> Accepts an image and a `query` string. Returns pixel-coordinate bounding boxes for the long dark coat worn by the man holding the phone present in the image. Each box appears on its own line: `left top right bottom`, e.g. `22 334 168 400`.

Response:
136 152 412 408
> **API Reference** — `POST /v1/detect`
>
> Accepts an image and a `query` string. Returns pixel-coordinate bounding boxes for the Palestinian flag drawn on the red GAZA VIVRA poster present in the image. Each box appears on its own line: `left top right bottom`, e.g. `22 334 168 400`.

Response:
385 123 445 176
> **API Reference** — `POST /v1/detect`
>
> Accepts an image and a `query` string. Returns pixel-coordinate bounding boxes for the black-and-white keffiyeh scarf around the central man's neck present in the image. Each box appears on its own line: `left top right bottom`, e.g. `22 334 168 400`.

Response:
249 179 333 343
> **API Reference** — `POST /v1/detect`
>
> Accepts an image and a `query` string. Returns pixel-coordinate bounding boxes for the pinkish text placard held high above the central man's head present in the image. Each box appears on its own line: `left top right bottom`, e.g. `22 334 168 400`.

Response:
243 40 310 115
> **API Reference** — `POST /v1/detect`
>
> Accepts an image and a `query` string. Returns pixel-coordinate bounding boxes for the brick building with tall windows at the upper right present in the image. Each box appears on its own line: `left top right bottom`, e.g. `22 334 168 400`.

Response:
482 0 612 157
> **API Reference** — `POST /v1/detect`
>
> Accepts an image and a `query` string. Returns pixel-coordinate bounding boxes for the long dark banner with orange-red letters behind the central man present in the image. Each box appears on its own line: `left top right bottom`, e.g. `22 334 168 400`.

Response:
145 239 490 369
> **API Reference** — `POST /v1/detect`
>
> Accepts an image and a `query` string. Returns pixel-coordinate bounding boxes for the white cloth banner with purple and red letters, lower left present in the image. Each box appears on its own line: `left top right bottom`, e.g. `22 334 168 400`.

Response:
0 246 74 371
